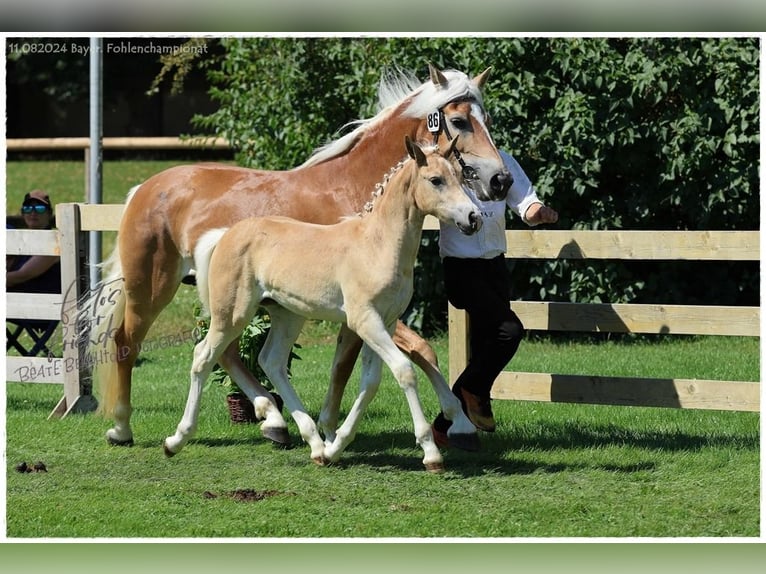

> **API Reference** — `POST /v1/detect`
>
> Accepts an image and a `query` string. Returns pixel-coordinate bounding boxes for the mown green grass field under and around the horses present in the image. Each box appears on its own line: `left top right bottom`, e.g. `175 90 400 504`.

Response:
5 162 760 539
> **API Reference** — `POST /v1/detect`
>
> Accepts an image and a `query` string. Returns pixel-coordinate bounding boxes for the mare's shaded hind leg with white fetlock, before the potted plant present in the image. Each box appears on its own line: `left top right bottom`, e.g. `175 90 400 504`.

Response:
219 339 290 446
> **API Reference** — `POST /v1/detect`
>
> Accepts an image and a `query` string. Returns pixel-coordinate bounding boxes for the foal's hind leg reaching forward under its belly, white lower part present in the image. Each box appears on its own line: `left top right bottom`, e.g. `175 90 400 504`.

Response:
258 305 325 464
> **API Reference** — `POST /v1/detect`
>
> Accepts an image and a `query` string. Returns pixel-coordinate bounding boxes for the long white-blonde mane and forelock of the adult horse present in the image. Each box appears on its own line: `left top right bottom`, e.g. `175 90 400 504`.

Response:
297 69 484 169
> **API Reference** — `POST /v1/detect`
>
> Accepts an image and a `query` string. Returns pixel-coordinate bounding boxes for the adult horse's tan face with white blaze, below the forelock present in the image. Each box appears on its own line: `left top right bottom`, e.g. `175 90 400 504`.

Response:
426 101 513 201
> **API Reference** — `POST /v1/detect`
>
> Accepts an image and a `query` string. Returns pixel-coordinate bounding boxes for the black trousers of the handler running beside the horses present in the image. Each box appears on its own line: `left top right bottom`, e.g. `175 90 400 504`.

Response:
443 255 524 397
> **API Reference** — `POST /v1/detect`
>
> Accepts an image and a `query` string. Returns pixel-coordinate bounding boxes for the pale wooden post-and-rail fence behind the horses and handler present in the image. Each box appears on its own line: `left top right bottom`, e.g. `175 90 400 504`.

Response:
6 207 760 416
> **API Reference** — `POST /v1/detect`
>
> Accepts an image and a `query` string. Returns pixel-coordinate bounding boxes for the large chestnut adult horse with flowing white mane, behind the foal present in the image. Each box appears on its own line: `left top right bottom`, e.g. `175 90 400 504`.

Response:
97 66 511 446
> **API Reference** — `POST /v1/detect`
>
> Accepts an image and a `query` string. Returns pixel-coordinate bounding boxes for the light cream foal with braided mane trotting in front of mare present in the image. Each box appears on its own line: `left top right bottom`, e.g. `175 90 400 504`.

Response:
165 137 481 472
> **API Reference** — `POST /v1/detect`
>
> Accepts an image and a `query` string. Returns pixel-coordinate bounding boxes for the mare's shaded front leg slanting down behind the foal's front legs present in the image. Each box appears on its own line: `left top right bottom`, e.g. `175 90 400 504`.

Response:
318 323 362 445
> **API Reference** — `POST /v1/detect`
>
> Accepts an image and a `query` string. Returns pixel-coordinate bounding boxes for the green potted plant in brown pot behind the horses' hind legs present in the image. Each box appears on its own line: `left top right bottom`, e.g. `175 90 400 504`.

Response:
194 304 300 423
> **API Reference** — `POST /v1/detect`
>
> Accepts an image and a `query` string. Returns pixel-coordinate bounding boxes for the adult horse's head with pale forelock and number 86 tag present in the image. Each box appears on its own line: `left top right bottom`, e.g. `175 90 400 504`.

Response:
418 65 513 201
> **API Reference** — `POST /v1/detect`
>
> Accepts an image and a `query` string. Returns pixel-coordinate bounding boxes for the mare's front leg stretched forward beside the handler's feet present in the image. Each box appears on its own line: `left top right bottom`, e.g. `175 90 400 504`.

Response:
393 321 479 451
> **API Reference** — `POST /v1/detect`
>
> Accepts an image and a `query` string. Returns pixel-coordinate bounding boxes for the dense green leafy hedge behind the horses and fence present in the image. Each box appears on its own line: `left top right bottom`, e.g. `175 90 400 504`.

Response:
182 37 760 332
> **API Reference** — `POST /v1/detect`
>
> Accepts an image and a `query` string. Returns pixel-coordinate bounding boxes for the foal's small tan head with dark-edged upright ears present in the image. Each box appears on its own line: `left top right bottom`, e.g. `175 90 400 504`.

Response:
404 136 482 235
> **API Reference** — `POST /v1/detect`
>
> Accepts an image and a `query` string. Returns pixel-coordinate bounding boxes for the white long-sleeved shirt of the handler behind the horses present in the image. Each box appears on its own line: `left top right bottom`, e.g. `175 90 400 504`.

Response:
439 151 542 259
